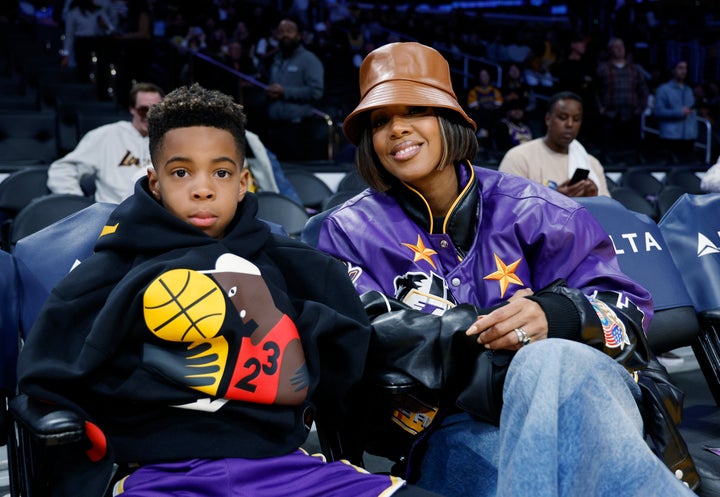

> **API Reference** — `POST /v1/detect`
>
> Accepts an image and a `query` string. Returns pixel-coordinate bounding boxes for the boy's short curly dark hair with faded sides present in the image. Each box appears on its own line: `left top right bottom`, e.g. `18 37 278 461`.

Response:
148 83 246 163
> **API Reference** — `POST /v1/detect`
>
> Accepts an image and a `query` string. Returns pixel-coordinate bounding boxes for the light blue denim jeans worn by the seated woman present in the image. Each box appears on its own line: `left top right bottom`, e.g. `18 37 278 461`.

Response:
417 339 695 497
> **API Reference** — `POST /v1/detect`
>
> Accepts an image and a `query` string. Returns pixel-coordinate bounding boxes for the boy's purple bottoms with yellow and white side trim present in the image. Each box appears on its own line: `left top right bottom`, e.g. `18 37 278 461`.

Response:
113 450 405 497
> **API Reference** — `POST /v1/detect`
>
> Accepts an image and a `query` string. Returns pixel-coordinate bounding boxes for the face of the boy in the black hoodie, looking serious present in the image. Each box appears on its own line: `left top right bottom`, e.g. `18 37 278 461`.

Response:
148 126 248 238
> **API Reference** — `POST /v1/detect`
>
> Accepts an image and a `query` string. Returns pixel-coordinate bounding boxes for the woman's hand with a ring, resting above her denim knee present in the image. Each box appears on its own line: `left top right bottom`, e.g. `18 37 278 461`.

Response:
465 289 548 350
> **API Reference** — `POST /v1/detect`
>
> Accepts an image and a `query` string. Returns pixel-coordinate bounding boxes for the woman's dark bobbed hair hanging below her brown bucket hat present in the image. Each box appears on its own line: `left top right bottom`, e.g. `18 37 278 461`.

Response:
355 107 478 192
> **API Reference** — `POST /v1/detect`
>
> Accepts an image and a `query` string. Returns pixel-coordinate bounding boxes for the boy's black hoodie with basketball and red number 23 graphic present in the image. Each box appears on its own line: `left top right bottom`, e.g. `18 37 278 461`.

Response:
18 179 370 463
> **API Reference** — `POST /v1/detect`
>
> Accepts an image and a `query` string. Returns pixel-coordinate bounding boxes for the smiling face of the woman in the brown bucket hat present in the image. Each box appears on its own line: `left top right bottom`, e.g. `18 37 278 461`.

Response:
370 105 453 189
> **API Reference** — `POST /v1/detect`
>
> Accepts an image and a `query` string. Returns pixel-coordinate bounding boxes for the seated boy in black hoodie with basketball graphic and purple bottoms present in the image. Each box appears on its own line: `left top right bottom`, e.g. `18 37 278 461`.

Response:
19 85 434 497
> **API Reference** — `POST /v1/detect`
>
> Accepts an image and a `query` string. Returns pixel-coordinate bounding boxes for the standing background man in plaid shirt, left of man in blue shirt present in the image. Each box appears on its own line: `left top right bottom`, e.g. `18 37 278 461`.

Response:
597 38 648 149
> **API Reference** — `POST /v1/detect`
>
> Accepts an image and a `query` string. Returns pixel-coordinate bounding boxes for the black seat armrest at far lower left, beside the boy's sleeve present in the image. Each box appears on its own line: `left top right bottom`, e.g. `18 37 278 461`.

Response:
8 394 85 446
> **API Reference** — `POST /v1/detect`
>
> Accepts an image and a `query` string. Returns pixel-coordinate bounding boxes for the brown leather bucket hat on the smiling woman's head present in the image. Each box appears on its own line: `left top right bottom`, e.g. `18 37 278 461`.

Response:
343 42 477 145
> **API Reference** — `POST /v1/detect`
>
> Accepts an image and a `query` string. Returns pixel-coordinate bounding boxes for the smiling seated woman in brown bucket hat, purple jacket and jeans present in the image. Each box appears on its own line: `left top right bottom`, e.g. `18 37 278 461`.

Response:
319 43 693 497
